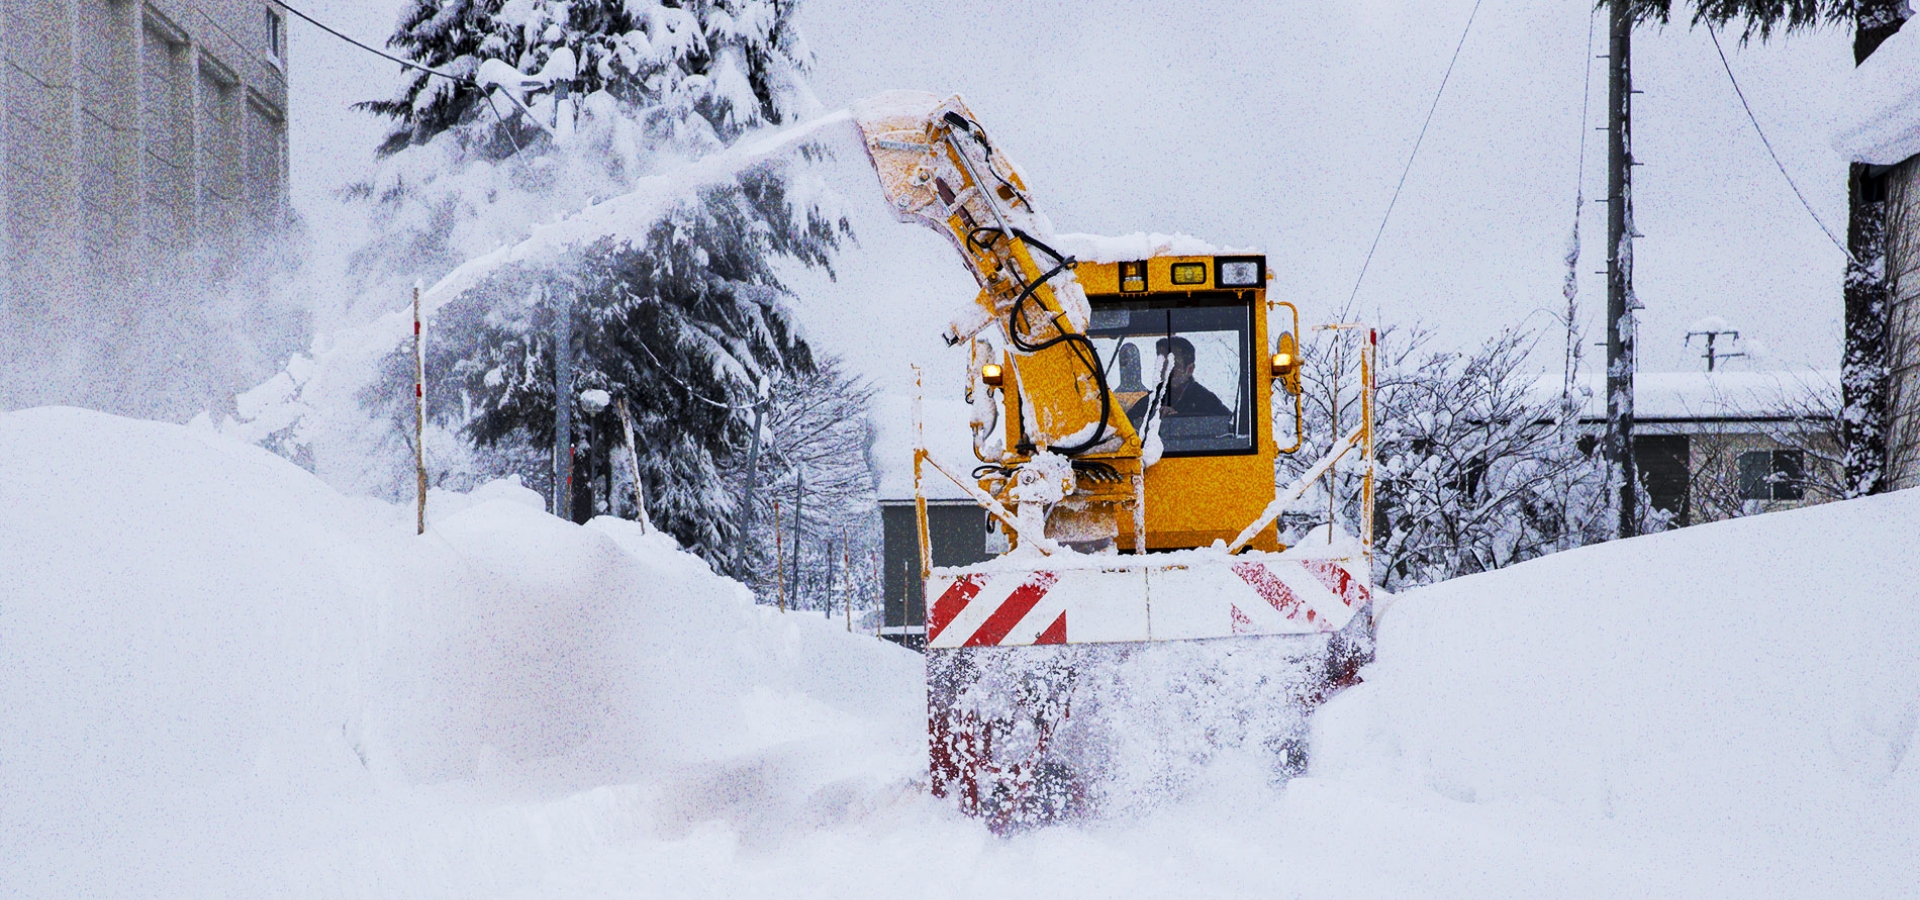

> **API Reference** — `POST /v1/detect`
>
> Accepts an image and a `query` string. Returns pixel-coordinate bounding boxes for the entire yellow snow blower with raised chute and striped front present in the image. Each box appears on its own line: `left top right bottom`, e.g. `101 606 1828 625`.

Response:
852 92 1373 829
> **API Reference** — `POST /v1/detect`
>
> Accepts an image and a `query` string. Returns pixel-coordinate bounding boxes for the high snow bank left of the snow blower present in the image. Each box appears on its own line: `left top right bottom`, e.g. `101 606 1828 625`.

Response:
0 409 922 896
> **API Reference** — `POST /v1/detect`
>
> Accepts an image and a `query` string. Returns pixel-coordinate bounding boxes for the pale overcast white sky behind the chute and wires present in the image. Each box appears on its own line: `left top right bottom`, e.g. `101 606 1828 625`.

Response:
292 0 1851 380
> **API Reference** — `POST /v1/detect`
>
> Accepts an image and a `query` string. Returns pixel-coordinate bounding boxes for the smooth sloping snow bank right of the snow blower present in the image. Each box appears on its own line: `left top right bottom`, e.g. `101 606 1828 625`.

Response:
1313 491 1920 896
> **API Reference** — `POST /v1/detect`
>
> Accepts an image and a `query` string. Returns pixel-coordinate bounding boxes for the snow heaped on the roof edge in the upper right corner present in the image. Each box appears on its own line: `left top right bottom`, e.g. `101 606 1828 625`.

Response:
1834 29 1920 165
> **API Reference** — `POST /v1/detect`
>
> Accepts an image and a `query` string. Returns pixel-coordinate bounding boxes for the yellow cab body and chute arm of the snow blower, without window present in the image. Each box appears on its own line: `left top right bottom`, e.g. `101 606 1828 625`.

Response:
854 92 1300 553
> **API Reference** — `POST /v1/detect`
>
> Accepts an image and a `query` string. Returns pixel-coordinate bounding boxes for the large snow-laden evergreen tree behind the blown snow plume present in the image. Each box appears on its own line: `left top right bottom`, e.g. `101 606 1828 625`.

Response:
355 0 847 572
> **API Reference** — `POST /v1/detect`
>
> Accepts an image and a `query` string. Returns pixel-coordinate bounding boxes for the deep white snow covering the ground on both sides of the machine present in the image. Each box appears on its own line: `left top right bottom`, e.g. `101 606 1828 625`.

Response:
0 409 1920 898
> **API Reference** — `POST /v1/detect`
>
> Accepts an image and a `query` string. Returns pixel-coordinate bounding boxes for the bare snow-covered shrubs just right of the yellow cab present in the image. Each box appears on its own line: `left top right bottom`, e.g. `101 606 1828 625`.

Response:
1281 330 1607 589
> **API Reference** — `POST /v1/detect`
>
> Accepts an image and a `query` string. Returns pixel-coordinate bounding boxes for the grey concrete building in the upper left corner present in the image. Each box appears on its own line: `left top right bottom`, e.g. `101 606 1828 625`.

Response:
0 0 290 407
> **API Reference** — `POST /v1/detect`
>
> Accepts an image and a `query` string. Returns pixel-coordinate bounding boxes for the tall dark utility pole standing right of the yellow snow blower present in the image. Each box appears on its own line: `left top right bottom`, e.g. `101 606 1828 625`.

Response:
1605 0 1640 537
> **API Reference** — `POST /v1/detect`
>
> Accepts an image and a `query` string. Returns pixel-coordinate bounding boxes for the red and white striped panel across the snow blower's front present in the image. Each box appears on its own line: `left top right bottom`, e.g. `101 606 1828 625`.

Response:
927 555 1373 649
